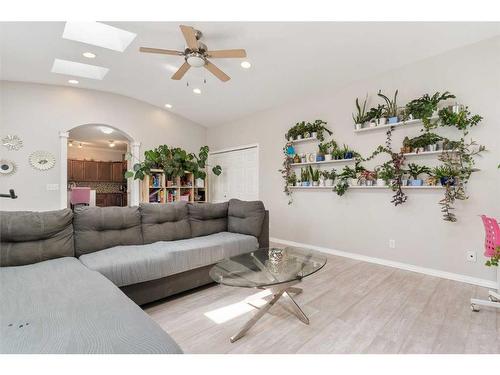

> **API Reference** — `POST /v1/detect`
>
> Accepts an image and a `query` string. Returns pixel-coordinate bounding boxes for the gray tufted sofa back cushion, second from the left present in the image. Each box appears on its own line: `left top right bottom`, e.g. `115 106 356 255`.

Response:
73 207 143 257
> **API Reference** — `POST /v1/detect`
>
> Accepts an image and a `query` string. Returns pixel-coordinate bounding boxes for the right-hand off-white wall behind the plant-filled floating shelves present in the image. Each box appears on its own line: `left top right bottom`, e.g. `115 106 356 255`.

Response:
207 38 500 280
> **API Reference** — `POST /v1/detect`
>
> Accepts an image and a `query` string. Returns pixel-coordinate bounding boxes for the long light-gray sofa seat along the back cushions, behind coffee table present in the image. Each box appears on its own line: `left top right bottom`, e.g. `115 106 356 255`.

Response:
80 232 258 286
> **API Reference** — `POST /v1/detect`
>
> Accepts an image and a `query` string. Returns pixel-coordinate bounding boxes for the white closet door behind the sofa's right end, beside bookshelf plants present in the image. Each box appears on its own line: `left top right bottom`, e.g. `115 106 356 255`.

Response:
209 146 259 203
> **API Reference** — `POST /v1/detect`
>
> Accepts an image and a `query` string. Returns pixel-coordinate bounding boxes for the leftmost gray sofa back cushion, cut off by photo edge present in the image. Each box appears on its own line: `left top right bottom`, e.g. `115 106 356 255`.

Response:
0 209 75 267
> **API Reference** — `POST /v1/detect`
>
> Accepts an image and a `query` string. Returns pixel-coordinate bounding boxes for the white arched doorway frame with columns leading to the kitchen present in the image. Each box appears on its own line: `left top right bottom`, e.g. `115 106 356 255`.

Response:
59 123 140 208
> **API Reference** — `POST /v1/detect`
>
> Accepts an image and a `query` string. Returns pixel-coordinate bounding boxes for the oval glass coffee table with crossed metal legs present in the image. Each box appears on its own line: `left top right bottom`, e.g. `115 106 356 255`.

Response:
210 247 326 342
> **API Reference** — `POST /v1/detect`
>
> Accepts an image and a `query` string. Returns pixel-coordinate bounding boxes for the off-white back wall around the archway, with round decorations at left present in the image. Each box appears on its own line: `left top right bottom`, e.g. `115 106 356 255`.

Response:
0 81 206 210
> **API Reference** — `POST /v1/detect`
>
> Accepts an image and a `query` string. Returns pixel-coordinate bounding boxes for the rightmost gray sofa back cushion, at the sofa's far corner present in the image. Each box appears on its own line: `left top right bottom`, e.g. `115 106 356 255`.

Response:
227 199 266 237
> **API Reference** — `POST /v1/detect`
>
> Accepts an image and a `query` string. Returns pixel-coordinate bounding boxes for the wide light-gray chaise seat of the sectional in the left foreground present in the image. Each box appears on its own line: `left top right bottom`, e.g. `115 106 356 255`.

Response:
0 258 181 353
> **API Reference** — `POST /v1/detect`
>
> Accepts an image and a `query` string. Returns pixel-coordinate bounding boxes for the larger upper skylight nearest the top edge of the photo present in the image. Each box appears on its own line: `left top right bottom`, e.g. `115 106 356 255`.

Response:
63 22 137 52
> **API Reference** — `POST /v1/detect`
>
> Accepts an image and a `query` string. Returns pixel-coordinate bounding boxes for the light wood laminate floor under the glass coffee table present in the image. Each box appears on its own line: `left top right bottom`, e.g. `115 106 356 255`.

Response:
145 245 500 353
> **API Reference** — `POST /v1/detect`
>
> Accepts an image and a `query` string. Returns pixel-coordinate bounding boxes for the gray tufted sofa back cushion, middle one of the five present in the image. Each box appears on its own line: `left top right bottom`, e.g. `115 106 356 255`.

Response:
140 202 191 243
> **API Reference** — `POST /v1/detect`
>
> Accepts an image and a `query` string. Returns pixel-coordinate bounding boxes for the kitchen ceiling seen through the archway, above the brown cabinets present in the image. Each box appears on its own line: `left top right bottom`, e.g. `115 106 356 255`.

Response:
68 124 128 151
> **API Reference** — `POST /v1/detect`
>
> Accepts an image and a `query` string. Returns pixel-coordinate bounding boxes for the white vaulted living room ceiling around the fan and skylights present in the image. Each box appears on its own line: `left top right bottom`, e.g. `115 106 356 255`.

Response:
0 22 500 126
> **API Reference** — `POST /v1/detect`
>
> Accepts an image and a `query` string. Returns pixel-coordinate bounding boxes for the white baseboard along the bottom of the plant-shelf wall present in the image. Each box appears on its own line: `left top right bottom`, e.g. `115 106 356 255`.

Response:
269 237 498 289
